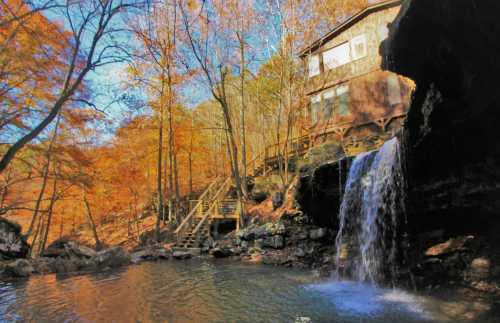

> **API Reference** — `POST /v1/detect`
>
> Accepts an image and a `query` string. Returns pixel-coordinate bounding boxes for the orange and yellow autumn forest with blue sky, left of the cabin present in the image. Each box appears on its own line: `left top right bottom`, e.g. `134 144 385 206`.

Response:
0 0 378 253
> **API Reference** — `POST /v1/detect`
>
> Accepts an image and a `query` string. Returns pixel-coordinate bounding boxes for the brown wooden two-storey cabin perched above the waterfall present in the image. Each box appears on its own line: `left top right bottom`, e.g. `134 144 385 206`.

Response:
300 0 415 155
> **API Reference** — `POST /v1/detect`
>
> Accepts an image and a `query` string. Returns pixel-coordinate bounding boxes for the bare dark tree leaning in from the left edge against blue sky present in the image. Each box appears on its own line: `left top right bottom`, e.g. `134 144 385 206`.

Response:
0 0 146 172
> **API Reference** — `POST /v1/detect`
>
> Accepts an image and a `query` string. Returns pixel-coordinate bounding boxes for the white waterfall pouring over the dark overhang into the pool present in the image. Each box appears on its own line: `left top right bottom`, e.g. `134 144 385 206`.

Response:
335 138 405 282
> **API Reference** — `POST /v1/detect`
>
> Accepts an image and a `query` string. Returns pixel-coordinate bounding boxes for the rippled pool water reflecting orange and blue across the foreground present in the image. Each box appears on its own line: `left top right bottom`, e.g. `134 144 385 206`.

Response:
0 260 488 323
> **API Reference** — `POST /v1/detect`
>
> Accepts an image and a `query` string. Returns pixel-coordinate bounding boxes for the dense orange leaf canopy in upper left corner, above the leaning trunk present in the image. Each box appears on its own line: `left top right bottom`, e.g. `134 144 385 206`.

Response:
0 0 81 137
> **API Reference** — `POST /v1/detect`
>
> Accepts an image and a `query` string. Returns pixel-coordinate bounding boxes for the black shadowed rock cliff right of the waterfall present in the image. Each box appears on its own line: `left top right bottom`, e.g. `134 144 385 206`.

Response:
381 0 500 288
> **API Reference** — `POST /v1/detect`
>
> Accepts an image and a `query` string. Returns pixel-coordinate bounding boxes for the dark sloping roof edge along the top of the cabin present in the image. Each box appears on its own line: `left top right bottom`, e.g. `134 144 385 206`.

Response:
299 0 403 58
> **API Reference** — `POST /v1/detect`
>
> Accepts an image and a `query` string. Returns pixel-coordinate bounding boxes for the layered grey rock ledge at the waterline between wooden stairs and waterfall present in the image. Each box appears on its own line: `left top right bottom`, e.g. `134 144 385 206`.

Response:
197 212 335 273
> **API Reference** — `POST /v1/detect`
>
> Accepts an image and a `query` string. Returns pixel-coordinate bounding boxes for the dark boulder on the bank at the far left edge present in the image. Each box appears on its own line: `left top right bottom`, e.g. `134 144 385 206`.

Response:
0 217 29 260
